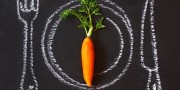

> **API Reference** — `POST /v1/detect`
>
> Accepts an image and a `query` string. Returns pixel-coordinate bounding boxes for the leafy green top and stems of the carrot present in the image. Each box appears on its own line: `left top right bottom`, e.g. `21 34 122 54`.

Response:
60 0 105 37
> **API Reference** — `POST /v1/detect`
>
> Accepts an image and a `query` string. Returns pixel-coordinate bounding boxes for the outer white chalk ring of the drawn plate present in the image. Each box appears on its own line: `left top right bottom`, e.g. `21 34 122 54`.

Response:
41 1 133 89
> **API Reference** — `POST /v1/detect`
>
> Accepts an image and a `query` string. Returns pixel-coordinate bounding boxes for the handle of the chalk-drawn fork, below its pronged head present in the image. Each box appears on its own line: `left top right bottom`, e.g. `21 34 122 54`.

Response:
20 21 38 90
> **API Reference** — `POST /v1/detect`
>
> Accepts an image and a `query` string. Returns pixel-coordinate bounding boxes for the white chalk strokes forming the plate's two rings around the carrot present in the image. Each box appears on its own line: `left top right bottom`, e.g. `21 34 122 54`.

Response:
41 0 134 89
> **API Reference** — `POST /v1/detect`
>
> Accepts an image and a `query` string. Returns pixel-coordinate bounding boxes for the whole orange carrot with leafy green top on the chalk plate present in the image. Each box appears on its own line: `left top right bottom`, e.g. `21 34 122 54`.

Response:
60 0 105 87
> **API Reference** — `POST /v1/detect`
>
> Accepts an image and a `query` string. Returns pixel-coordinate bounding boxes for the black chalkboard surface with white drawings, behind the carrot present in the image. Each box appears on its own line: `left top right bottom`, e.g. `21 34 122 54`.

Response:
0 0 180 90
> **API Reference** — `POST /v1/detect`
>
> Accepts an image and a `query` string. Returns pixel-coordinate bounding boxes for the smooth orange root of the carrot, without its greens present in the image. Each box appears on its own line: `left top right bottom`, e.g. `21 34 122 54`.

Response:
81 37 95 87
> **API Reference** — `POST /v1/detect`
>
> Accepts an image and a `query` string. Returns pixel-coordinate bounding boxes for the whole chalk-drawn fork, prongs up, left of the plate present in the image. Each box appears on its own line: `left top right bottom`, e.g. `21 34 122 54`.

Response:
17 0 39 90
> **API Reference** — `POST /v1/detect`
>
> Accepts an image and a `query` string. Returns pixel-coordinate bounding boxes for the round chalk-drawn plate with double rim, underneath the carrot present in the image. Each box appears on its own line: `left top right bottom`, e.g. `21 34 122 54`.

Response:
41 0 133 89
